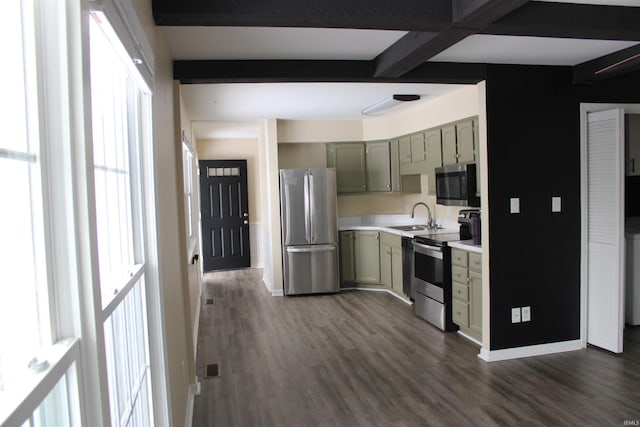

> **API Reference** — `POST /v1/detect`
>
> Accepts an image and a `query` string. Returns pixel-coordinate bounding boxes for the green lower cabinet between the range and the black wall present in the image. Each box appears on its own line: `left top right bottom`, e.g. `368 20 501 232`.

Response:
451 248 482 341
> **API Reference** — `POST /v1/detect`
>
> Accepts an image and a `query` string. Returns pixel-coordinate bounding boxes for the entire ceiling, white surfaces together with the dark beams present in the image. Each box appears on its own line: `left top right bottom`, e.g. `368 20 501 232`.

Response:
154 0 640 130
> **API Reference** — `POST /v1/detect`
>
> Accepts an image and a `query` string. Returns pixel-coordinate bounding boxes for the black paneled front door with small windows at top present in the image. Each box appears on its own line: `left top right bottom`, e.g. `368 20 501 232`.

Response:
199 160 251 271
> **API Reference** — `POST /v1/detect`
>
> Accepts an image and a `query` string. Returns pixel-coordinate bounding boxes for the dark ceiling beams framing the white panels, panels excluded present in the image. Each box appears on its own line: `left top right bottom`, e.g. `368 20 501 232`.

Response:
152 0 640 83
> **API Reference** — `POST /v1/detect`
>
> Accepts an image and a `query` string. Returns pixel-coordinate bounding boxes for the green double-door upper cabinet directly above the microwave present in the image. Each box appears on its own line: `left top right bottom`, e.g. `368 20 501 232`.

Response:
441 118 478 165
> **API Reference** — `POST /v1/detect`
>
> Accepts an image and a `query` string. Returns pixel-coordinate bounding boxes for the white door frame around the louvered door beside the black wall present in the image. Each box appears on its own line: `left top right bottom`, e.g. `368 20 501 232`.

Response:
580 103 640 348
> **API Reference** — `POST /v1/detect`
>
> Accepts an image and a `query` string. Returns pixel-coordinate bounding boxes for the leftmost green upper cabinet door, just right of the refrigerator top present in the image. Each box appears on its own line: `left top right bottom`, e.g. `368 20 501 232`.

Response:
333 143 367 193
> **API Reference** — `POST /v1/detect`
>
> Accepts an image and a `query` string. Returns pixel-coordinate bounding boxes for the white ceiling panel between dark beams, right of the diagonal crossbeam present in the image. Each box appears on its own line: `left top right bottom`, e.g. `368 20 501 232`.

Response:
431 35 638 66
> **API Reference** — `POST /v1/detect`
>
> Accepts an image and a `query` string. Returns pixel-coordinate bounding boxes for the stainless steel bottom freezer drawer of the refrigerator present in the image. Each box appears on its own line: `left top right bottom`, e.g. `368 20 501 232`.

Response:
283 244 340 295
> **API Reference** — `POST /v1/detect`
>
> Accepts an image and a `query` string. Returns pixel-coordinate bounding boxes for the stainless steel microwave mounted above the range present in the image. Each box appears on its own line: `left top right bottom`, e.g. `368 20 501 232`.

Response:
436 163 480 207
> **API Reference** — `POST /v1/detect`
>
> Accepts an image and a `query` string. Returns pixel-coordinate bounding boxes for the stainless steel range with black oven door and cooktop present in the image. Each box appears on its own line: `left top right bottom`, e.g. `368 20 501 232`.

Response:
411 233 460 331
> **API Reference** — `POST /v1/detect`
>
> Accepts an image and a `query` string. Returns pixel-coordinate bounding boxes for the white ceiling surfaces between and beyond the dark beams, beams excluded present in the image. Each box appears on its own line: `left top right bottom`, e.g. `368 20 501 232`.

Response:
164 0 640 138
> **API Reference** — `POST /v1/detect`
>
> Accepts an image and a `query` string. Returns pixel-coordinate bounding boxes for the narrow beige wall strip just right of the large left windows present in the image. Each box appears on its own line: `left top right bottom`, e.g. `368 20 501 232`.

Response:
134 0 195 426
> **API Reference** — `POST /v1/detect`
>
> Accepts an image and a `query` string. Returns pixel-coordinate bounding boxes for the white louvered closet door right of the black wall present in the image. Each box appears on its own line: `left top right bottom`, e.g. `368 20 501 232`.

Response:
587 109 624 353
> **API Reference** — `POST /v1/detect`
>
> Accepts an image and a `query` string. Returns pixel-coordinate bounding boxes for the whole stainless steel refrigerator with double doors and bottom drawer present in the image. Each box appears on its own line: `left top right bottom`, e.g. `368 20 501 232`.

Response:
280 168 340 295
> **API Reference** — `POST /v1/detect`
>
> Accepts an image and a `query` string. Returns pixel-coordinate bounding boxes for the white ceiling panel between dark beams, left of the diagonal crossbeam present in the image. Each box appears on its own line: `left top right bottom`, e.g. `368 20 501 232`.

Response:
163 27 406 60
